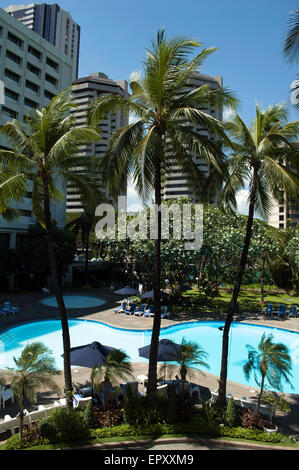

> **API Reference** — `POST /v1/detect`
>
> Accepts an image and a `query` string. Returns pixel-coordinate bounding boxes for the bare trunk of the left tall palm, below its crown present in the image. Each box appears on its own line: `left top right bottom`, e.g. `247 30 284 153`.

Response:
42 174 73 410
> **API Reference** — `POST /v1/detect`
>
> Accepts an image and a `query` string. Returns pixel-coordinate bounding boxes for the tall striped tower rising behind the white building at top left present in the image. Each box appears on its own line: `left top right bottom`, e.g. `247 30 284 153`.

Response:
5 3 80 80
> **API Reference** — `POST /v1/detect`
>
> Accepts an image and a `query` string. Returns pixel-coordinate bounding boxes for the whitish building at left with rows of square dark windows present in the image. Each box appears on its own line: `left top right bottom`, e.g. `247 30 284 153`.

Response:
0 8 72 264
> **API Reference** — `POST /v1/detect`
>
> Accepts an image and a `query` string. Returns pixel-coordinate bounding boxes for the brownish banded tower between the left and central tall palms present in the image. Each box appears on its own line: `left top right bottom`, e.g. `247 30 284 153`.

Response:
66 72 129 212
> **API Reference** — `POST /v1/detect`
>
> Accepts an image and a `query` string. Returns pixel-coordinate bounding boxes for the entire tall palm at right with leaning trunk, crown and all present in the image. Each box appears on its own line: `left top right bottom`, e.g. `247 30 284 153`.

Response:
217 104 299 406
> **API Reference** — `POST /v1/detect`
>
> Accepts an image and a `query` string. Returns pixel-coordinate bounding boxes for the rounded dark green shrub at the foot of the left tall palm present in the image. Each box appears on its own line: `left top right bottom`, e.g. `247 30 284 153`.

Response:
39 408 89 443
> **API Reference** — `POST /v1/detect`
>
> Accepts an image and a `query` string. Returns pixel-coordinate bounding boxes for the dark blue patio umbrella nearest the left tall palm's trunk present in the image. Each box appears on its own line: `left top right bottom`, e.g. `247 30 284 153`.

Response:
62 341 116 369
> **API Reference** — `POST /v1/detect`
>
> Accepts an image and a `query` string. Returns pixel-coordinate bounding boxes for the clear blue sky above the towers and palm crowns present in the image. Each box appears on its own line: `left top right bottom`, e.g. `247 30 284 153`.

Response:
1 0 298 213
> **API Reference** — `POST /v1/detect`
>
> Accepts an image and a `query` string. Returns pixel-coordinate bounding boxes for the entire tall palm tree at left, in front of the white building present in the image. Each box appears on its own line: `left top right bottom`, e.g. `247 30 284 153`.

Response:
0 90 100 409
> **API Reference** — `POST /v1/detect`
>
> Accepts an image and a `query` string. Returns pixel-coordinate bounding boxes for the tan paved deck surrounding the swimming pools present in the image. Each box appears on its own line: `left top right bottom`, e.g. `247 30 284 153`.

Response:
0 290 299 436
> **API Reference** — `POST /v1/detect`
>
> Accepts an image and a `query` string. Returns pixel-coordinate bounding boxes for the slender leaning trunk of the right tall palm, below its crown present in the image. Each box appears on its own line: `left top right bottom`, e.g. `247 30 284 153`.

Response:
216 165 258 407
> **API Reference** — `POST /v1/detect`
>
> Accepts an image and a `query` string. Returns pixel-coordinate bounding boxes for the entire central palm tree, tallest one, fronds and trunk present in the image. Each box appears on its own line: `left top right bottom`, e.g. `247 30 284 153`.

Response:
90 30 235 396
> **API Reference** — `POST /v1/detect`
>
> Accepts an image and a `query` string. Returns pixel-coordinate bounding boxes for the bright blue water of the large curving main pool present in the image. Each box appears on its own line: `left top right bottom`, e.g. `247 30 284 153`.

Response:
0 320 299 394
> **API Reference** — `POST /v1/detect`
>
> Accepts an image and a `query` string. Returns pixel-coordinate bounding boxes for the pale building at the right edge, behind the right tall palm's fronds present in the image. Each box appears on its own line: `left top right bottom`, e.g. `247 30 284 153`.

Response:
268 141 299 229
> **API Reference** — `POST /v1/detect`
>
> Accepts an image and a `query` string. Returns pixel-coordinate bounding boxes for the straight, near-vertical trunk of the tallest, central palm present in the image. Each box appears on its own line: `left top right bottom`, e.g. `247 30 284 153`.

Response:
147 162 161 398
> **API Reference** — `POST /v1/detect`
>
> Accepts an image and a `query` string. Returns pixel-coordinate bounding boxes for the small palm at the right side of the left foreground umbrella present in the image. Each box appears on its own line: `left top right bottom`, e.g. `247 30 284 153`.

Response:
90 349 133 408
